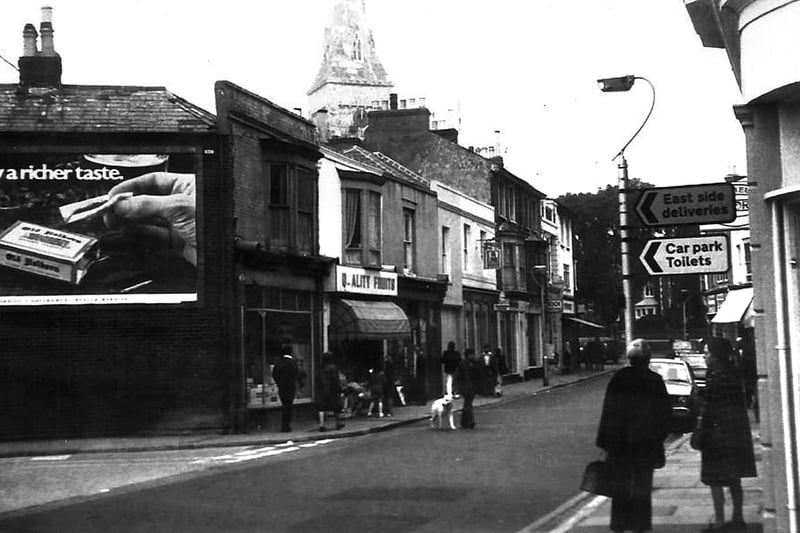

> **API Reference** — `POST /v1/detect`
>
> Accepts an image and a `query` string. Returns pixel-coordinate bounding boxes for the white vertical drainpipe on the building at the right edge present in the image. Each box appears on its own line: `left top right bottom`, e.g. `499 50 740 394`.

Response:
771 200 797 533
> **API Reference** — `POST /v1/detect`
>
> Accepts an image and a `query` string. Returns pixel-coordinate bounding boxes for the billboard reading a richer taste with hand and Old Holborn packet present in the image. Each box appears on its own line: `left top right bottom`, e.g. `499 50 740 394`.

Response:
0 153 198 306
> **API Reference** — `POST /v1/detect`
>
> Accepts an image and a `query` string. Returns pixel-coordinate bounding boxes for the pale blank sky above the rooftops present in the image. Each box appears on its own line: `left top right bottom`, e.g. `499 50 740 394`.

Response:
0 0 747 198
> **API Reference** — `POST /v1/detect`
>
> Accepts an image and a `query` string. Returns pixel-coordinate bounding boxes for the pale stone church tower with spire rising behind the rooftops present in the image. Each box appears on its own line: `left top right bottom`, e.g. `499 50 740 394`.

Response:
308 0 394 142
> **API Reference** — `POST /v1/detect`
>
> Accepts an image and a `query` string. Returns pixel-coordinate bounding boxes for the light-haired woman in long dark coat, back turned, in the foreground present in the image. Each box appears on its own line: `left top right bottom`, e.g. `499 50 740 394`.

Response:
597 339 671 532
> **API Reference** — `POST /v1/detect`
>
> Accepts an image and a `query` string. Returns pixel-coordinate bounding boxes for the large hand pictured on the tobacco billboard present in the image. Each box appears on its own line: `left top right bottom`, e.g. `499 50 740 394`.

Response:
103 172 197 265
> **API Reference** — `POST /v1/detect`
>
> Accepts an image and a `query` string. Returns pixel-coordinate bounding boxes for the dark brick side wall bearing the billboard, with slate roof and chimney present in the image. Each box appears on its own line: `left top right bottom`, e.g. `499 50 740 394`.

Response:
0 9 228 438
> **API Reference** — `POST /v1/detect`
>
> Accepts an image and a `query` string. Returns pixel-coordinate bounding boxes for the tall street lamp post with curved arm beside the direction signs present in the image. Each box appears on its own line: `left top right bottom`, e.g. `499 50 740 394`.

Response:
597 75 656 346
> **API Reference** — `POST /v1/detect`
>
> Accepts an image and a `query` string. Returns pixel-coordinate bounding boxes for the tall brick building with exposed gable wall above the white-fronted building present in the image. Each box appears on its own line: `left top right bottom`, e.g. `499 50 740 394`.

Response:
364 103 547 376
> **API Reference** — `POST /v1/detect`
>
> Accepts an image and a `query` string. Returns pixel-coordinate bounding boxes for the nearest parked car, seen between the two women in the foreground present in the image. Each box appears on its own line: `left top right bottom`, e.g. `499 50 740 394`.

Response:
650 358 698 433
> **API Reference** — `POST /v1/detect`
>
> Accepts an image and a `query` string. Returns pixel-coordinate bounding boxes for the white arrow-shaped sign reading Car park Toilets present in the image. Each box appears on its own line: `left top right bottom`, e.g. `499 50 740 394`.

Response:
639 235 728 276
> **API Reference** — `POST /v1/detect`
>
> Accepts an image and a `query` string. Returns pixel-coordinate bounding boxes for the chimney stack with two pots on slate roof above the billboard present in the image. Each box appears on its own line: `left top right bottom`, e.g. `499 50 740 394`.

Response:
18 6 61 90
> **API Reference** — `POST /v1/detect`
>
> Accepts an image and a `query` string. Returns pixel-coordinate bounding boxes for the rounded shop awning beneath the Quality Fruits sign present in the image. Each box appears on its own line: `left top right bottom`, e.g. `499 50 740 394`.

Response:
329 299 411 339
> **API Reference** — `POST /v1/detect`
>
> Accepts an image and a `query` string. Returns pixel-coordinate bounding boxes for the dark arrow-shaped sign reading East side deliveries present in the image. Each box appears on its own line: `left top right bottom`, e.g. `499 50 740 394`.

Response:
635 183 736 226
